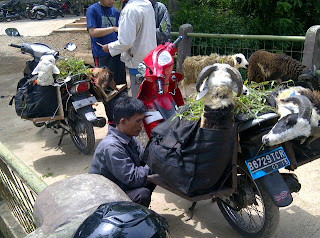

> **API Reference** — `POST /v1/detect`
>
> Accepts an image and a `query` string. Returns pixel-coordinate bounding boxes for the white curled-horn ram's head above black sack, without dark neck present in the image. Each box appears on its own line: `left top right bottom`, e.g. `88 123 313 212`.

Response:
196 63 243 108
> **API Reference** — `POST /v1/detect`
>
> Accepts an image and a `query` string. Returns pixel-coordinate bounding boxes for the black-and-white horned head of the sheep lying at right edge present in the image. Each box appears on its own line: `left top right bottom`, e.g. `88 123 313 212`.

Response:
262 95 313 146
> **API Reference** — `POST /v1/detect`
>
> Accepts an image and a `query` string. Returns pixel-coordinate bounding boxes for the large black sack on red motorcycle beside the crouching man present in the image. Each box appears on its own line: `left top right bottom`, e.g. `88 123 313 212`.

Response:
143 108 236 196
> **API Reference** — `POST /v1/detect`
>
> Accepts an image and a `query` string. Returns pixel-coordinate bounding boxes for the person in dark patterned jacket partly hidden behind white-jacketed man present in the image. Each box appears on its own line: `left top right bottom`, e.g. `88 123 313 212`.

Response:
150 0 171 45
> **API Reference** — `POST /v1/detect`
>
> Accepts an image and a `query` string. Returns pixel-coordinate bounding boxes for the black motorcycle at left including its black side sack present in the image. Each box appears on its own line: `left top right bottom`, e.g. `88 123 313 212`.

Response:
6 28 106 154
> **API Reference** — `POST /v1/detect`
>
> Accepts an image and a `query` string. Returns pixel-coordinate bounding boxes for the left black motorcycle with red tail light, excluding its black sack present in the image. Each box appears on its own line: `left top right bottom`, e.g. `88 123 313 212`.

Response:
5 28 106 154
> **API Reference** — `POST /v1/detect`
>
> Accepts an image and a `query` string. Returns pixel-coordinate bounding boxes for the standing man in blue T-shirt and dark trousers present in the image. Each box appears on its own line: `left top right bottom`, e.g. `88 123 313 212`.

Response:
86 0 127 123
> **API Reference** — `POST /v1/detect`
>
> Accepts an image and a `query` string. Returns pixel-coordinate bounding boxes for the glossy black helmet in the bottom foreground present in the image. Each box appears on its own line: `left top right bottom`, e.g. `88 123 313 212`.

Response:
73 202 170 238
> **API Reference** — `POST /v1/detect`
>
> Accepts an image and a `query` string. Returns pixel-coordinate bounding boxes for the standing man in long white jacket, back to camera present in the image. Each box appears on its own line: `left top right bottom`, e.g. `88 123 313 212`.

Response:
102 0 157 97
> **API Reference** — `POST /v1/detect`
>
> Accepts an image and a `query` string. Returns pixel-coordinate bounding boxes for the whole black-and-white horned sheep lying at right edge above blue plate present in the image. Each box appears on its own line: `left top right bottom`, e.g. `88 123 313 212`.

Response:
262 87 320 146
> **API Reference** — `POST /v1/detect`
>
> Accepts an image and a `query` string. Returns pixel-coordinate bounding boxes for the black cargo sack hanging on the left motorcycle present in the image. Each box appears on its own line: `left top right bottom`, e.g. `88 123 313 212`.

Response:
14 77 58 119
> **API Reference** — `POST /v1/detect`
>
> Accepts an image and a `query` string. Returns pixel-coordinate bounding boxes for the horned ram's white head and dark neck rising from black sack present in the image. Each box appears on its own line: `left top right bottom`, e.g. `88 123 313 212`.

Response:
196 63 243 129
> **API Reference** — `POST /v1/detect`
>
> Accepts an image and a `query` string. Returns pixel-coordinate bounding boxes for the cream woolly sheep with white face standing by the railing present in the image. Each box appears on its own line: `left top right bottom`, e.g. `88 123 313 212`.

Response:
182 53 248 86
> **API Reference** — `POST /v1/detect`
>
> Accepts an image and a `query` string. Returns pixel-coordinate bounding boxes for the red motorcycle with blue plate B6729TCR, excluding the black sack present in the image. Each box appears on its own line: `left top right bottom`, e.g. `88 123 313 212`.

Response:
137 36 320 237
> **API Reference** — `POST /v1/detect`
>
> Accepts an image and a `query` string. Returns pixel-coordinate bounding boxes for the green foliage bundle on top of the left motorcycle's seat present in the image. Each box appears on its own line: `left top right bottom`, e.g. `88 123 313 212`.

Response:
56 57 89 78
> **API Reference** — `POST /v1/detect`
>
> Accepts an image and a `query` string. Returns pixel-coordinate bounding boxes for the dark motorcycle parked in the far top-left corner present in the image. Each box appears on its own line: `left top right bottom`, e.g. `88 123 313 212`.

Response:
0 0 25 21
